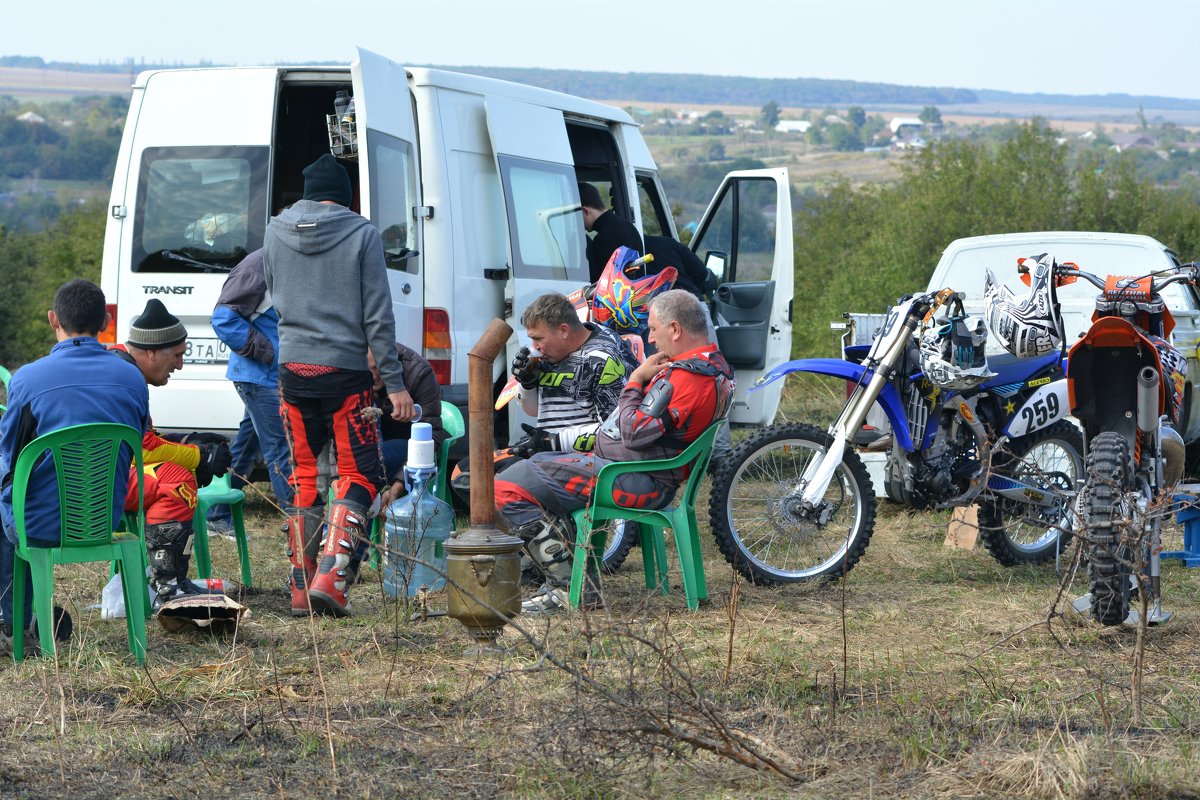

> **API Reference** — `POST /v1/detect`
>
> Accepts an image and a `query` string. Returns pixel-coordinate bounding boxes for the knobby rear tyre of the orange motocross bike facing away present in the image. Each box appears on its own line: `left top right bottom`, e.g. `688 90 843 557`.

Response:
1084 432 1134 625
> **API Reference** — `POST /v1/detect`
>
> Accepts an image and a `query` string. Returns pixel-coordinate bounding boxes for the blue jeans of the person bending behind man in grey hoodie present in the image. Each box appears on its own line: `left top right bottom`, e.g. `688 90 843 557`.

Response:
209 380 292 521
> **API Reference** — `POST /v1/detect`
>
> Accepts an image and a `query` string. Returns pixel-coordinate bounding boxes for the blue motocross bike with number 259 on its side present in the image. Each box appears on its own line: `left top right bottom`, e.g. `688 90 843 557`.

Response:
709 289 1082 585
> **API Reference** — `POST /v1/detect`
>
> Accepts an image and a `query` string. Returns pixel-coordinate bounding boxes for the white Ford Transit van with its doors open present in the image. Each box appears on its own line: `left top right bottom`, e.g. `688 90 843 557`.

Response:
102 49 793 431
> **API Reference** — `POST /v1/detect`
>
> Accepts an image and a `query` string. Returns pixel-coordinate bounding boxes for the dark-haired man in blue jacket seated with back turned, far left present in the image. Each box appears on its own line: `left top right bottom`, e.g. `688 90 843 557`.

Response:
0 279 150 654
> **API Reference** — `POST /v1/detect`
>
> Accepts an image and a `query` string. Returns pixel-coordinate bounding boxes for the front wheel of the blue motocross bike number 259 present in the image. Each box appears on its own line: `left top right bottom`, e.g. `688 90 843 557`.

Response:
708 425 875 585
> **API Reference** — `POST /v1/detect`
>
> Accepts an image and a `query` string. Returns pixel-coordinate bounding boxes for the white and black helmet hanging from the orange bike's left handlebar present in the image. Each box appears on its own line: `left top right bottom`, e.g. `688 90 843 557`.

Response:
983 253 1062 359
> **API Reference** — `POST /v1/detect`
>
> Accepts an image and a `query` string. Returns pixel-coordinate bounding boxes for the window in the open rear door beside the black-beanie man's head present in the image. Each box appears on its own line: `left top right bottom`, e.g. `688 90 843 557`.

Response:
367 130 420 272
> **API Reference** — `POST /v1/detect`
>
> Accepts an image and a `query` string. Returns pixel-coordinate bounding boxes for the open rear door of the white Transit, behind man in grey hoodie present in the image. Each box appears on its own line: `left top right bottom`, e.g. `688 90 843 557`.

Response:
350 48 427 353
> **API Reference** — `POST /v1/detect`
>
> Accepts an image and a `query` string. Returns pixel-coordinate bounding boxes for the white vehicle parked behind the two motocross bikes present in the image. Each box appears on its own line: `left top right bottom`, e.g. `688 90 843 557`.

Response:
928 230 1200 443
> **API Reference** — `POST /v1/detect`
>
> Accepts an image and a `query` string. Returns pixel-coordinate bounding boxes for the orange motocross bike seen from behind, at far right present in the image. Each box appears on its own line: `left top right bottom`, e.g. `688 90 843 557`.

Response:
988 254 1198 625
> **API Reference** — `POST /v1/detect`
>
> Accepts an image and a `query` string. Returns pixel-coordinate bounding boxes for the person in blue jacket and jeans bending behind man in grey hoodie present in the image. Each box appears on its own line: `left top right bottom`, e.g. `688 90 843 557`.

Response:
208 248 292 534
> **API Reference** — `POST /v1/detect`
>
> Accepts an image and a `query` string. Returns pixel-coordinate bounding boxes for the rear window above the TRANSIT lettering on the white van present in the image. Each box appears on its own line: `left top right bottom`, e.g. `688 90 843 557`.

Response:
131 148 269 272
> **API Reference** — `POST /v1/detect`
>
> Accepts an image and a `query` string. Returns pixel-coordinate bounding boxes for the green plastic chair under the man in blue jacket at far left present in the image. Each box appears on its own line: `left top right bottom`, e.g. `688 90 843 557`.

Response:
12 422 146 664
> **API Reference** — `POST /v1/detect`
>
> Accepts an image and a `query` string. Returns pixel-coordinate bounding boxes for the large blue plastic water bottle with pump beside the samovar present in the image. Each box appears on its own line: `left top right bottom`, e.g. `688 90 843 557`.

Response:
383 422 454 597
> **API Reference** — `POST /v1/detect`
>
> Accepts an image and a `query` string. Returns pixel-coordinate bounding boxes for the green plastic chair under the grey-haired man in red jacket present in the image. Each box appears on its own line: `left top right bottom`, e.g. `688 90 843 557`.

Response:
569 422 721 610
